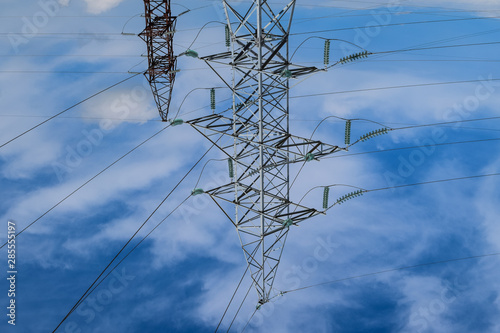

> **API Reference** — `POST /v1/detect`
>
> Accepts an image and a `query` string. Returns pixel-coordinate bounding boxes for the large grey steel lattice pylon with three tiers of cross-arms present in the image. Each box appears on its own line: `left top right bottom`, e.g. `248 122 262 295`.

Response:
187 0 343 304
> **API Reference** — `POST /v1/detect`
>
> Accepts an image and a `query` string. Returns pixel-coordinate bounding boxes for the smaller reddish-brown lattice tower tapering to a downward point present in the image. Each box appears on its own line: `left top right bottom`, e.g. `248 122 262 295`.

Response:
139 0 177 121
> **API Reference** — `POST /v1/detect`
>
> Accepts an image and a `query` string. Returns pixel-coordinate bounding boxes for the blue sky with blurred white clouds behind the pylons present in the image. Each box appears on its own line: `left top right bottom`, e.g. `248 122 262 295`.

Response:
0 0 500 333
